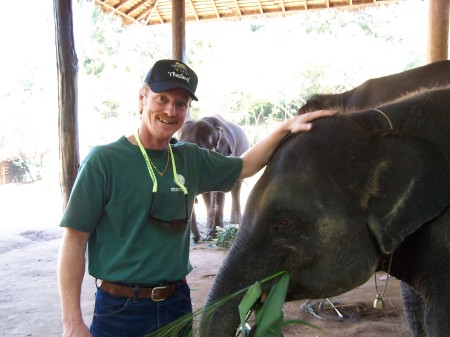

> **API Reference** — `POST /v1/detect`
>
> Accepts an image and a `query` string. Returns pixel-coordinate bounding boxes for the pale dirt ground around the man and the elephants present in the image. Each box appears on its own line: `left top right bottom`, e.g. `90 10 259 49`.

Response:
0 183 410 337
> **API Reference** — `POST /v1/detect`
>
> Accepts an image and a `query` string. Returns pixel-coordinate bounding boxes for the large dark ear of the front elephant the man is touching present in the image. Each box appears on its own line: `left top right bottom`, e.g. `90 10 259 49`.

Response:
367 134 450 254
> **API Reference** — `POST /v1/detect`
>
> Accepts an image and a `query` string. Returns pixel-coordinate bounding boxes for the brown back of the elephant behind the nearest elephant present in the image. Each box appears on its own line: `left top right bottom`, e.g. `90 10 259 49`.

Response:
299 60 450 113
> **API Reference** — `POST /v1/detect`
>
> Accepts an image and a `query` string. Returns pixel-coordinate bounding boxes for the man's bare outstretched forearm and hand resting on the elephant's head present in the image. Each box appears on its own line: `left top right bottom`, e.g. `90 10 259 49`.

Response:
239 110 336 179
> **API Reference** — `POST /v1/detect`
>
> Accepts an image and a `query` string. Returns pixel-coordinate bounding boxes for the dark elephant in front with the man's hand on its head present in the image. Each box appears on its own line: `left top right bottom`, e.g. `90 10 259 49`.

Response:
201 87 450 337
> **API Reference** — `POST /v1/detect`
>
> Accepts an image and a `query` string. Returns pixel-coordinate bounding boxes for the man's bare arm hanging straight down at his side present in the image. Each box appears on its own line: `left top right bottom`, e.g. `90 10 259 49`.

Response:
58 227 91 337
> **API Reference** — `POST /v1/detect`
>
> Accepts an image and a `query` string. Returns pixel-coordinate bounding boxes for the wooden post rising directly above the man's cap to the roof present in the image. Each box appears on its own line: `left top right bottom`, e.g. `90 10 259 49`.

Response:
172 0 186 62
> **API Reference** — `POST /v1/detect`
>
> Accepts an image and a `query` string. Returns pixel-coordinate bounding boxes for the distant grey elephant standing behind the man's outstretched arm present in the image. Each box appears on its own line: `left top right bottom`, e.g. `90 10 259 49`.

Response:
179 115 249 242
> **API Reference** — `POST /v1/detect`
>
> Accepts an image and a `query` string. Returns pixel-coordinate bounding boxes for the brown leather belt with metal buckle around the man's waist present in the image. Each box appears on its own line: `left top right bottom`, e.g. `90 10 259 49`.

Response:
100 279 186 302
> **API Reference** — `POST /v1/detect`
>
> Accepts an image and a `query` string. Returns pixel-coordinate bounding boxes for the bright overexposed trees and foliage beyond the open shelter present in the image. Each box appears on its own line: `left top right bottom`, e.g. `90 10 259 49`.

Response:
0 0 428 181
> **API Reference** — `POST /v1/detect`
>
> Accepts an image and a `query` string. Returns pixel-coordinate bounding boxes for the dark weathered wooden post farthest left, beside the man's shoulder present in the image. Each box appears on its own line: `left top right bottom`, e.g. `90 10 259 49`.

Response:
53 0 80 209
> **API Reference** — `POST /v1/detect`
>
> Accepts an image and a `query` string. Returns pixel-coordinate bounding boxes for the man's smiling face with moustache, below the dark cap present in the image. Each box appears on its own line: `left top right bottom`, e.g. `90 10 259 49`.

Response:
139 86 192 141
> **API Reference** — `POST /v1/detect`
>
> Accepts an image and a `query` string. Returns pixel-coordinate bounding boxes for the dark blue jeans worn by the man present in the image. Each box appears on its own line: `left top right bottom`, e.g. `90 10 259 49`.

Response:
90 283 192 337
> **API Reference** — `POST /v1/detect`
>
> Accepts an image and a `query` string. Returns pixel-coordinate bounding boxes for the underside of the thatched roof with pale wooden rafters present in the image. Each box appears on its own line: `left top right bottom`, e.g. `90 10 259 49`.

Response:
95 0 398 25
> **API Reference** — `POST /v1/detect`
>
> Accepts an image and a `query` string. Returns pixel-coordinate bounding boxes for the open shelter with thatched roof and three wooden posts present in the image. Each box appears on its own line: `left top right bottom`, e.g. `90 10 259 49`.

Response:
53 0 450 207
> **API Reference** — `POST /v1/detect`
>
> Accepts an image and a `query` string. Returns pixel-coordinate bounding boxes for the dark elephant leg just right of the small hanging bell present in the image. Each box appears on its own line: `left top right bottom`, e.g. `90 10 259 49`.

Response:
400 282 427 337
